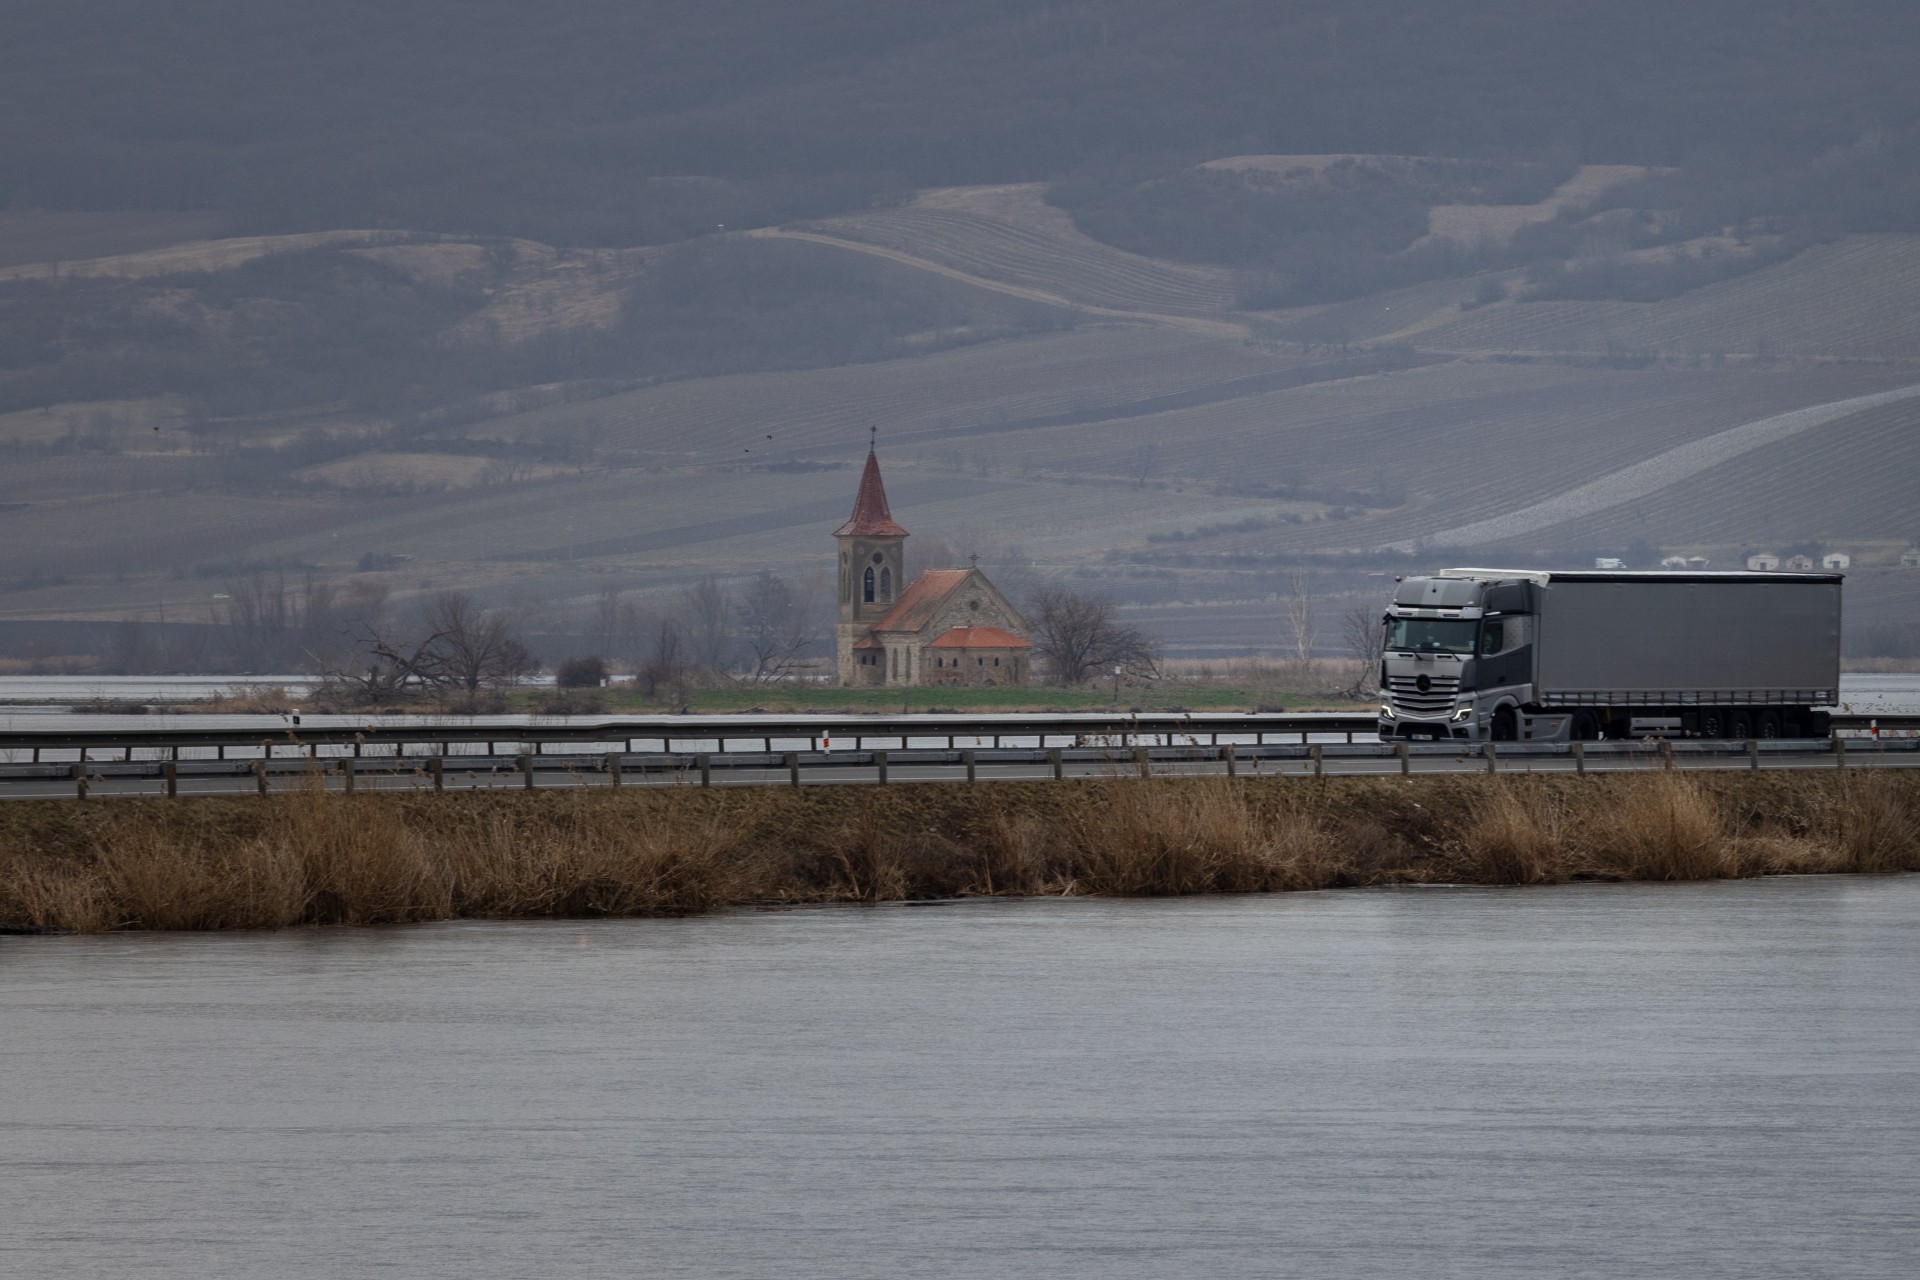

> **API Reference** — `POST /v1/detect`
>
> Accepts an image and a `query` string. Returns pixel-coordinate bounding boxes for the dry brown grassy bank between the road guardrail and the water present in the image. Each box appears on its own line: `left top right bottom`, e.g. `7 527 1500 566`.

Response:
0 771 1920 931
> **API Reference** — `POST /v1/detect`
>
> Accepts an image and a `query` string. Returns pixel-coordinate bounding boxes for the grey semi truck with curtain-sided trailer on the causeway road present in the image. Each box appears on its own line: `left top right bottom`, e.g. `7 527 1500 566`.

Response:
1380 568 1843 743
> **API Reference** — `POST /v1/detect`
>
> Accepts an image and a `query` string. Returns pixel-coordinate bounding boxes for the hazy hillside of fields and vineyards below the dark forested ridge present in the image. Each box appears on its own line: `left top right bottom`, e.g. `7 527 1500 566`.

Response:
0 151 1920 667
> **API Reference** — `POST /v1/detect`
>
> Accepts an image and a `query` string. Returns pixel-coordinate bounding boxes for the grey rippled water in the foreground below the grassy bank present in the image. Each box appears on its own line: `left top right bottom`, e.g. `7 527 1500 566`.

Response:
0 877 1920 1280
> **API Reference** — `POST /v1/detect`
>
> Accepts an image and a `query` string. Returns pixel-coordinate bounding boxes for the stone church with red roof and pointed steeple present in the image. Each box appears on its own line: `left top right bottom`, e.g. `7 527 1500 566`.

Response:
833 449 1033 687
